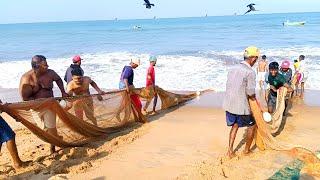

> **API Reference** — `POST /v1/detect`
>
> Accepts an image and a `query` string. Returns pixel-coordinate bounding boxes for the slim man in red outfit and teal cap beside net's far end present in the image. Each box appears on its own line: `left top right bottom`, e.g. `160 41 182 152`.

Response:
143 56 158 114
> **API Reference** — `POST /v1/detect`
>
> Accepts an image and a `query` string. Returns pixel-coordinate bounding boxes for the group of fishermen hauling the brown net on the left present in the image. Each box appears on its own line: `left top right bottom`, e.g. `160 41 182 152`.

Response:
0 55 157 168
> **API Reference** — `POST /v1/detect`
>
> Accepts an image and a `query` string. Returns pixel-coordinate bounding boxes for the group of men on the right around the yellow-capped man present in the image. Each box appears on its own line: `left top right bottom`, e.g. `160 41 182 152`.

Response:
223 47 307 158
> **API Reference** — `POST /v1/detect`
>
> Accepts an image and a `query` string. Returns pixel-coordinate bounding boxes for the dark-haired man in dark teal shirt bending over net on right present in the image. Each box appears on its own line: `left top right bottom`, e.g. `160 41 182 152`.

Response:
267 62 293 113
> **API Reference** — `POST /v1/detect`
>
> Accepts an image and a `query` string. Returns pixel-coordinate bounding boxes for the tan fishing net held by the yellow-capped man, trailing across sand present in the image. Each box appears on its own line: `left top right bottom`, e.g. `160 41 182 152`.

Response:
249 88 320 178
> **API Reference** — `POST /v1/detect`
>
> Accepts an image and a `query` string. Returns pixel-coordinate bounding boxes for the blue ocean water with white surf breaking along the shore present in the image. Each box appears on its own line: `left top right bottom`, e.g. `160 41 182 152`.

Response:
0 13 320 91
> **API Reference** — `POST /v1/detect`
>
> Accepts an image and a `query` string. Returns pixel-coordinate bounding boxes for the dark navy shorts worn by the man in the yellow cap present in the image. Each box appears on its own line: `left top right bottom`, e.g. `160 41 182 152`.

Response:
226 111 256 127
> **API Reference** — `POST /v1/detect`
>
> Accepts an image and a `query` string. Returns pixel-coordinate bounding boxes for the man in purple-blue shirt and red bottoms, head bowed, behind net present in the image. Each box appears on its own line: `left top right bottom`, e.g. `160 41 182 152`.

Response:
119 58 146 123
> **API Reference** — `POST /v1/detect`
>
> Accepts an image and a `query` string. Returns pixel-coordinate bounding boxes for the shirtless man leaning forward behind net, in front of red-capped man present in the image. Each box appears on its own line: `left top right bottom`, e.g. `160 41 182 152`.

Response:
67 68 104 125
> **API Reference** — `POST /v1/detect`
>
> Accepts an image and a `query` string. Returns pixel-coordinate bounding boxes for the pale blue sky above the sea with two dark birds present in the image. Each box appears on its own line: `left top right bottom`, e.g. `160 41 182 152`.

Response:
0 0 320 24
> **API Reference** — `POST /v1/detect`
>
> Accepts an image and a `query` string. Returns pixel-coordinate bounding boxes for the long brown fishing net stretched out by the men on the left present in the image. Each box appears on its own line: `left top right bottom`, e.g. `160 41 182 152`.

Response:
0 87 197 147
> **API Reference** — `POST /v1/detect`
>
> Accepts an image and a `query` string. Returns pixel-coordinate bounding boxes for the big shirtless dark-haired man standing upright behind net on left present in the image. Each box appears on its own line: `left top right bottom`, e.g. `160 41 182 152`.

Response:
19 55 68 153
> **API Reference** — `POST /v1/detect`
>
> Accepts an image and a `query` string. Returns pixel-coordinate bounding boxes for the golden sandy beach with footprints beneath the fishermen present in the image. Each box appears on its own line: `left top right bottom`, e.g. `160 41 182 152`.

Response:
0 92 320 179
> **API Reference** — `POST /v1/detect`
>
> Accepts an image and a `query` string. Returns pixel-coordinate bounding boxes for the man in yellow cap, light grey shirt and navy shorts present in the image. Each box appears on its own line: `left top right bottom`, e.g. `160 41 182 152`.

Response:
223 47 260 158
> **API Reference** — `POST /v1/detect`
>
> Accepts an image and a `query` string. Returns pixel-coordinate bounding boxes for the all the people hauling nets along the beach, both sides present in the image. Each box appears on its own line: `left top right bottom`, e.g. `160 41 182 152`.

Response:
0 47 307 168
